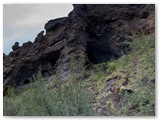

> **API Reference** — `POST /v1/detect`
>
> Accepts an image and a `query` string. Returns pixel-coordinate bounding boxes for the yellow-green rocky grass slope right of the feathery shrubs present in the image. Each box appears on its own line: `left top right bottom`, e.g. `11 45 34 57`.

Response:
94 35 155 116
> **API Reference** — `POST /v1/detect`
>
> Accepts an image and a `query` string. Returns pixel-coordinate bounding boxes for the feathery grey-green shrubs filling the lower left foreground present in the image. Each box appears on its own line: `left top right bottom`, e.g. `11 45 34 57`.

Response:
3 72 95 116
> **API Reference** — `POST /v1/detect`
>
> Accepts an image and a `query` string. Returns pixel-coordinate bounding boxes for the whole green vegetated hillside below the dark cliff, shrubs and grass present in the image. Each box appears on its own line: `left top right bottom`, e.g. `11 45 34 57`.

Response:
3 35 155 116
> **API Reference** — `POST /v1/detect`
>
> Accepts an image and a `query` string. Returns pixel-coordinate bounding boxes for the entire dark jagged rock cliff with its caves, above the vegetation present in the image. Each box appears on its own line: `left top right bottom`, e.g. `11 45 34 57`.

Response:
3 4 155 91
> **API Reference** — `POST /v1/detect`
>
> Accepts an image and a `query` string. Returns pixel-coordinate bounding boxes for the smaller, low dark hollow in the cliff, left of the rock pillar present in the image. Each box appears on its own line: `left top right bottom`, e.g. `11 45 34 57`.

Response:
15 51 60 86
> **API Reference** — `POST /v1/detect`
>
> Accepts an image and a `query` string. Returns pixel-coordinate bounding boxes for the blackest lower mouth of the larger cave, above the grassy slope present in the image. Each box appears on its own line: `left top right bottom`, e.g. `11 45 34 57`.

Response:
87 28 117 64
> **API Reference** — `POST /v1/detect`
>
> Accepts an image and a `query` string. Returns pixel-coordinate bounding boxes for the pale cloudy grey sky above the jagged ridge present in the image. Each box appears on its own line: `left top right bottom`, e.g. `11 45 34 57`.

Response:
3 4 73 54
